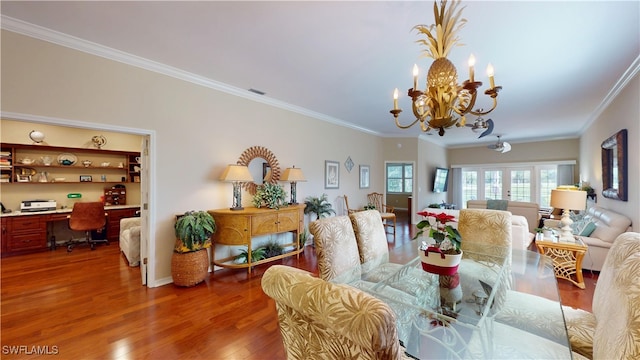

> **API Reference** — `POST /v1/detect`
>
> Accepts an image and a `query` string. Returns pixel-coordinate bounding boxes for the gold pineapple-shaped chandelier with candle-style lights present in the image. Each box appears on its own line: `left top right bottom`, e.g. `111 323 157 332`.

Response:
391 0 502 136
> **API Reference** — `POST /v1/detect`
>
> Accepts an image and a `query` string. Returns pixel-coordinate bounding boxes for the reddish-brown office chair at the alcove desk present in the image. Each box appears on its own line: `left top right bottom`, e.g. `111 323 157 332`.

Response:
67 202 109 252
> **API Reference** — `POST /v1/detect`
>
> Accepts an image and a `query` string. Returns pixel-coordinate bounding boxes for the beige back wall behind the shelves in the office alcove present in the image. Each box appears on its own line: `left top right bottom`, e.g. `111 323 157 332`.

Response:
0 119 142 210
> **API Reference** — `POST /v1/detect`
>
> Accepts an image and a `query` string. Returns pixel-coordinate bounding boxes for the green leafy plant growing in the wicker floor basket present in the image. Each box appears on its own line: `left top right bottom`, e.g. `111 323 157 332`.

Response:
174 210 216 253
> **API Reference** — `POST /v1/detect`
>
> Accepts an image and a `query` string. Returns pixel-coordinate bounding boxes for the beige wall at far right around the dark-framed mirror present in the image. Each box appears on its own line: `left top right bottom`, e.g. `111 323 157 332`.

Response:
580 75 640 231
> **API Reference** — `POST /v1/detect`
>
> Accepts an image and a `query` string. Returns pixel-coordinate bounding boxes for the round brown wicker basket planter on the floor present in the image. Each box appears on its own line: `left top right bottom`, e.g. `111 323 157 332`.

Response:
171 249 209 286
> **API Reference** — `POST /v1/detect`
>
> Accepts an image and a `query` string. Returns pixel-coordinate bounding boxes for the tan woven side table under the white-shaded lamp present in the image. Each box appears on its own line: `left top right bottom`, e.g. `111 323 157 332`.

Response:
536 238 588 289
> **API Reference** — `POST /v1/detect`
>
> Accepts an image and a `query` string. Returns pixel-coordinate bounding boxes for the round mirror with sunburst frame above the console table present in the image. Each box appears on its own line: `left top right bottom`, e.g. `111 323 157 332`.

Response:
237 146 280 195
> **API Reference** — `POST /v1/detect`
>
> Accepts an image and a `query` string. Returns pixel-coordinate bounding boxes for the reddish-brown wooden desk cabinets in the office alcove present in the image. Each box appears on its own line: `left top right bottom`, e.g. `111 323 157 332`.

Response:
0 205 140 257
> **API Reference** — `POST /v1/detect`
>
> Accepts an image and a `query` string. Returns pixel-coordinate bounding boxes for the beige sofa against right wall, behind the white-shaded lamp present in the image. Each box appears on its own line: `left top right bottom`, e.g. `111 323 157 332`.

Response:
544 206 631 271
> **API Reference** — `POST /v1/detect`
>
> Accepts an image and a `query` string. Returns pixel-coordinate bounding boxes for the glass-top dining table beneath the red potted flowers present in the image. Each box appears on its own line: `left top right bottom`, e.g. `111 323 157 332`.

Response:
359 241 571 359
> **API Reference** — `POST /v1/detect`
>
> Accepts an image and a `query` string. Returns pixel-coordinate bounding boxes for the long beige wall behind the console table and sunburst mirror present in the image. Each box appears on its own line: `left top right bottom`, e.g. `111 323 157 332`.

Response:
1 31 384 286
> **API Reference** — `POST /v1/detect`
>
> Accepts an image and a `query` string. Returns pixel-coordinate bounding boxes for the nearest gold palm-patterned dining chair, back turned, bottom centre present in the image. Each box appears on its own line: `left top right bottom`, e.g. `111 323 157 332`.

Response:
262 265 412 360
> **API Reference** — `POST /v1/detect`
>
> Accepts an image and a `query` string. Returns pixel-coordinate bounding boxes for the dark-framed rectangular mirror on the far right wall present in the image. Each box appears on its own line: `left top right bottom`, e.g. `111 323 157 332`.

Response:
602 129 629 201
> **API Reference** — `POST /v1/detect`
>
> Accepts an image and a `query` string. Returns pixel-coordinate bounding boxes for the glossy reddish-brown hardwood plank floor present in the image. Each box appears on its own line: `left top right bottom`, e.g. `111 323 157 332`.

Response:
0 213 597 359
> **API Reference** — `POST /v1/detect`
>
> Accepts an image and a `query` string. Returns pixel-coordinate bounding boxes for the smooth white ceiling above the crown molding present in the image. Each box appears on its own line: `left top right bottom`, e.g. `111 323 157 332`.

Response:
1 0 640 146
